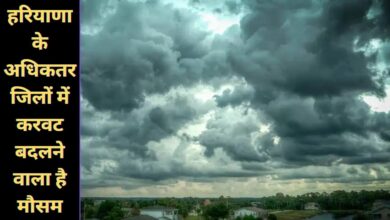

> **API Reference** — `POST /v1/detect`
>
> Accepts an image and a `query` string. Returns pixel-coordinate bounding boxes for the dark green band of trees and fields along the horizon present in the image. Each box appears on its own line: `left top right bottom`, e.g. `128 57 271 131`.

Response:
81 190 390 220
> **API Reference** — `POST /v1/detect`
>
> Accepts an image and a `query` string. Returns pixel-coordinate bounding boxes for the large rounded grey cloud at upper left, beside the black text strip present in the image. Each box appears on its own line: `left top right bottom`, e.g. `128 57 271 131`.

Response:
82 1 224 110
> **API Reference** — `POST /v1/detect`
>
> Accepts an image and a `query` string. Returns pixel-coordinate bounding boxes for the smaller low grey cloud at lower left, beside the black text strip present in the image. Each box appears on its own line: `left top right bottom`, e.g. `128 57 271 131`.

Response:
81 93 209 172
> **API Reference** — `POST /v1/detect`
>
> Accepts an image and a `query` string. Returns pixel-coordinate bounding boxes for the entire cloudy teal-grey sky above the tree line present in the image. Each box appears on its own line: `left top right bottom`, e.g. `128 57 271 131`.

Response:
81 0 390 197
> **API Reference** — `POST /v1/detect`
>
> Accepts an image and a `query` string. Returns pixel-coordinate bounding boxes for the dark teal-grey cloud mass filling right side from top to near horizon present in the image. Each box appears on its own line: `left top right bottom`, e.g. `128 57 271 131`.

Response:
222 0 390 168
